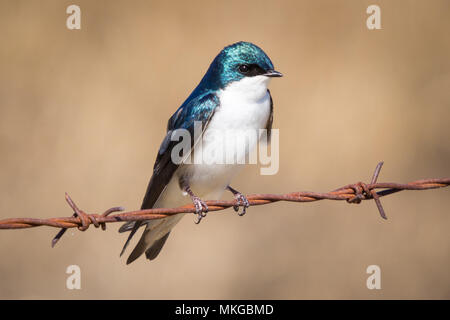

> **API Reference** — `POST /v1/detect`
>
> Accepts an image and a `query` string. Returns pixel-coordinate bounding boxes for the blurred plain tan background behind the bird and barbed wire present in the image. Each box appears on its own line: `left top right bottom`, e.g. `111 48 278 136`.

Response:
0 0 450 299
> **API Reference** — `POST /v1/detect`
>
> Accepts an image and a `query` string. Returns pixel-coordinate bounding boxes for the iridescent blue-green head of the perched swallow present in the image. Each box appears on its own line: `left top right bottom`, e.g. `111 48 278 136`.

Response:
199 41 282 90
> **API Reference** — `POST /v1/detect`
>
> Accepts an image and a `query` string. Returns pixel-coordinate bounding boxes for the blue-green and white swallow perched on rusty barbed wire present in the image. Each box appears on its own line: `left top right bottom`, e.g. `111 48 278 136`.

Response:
119 41 283 264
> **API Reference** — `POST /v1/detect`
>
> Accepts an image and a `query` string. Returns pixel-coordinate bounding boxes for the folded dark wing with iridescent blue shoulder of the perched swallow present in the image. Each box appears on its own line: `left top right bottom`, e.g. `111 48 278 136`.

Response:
119 91 220 255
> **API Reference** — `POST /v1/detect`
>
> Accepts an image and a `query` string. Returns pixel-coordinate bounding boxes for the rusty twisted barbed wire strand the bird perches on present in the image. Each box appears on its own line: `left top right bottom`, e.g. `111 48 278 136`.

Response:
0 162 450 246
